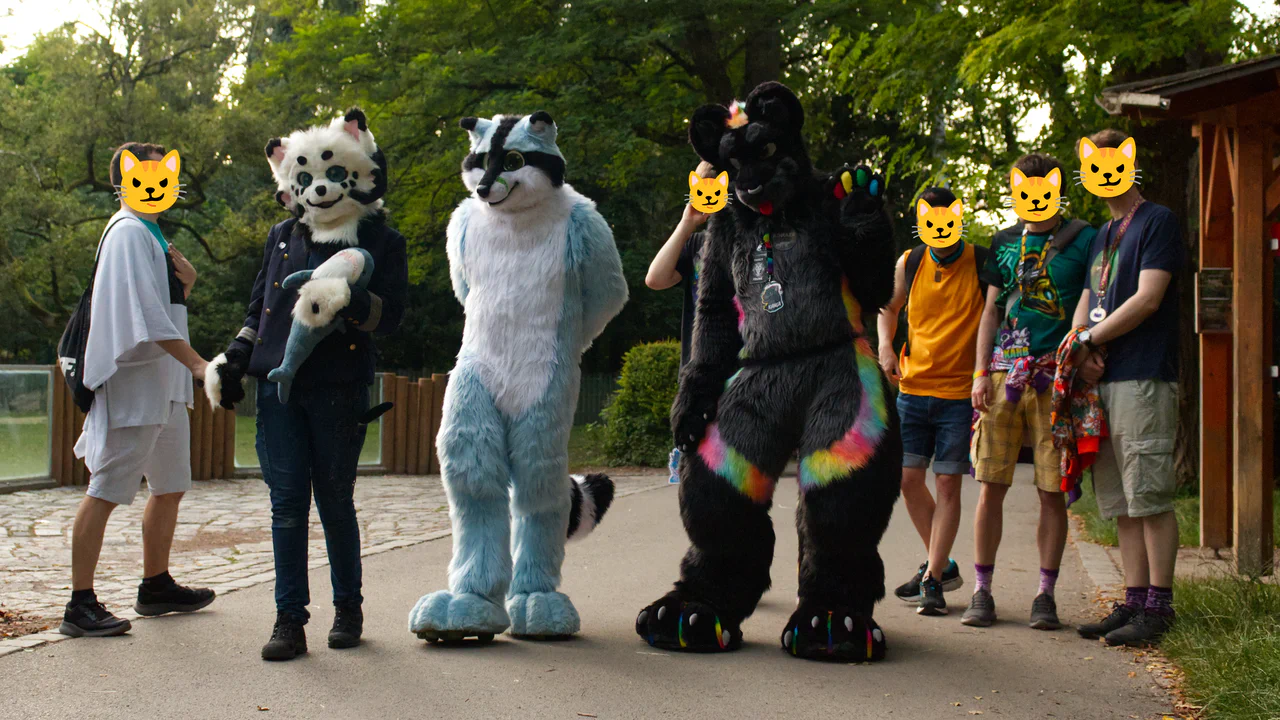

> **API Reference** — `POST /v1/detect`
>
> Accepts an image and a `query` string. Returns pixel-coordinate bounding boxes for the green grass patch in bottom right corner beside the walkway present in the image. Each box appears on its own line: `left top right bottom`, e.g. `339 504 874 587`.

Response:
1161 578 1280 720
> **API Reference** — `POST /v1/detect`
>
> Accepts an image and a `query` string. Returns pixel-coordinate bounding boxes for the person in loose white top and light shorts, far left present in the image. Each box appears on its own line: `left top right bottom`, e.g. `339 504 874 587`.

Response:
59 142 214 637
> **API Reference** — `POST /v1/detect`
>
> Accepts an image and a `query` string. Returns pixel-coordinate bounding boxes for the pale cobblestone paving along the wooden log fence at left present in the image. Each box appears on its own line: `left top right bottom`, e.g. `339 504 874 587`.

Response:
0 473 667 635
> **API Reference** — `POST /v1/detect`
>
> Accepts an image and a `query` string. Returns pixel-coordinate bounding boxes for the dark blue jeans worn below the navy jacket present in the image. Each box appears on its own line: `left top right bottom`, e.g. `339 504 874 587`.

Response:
257 379 369 623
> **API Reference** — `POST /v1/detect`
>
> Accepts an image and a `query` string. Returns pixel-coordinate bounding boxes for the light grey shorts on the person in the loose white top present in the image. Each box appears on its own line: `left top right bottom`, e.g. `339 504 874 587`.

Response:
88 402 191 505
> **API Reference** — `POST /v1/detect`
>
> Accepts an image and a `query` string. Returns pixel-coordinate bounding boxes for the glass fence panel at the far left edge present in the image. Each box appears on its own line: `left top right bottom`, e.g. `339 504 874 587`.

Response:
0 365 54 480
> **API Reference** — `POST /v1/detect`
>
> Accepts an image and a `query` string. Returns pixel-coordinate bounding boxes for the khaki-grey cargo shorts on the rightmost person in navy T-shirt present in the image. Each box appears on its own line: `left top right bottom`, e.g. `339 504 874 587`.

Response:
1093 380 1178 519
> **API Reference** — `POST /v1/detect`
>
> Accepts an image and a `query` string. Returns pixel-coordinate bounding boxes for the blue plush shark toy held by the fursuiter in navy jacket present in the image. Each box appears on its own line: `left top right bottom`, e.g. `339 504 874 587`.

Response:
266 247 374 402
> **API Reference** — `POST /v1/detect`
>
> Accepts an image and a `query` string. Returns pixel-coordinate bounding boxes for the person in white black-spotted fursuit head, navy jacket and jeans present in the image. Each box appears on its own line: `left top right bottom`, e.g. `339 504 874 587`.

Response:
205 109 408 660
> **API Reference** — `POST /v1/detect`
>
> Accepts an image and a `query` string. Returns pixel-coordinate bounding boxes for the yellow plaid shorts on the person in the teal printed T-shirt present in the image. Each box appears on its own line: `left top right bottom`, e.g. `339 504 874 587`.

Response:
969 373 1062 492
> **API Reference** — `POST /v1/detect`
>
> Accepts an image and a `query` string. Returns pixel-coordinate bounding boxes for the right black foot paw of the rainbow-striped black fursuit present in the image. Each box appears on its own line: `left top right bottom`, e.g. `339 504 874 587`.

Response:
782 602 884 662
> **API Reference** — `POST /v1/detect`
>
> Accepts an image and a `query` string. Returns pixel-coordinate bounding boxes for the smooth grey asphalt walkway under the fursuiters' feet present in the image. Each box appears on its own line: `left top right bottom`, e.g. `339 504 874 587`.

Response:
0 468 1170 720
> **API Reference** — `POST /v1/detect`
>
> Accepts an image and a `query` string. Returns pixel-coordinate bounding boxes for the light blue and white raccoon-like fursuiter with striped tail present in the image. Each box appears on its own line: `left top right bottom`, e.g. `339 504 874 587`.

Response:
408 111 627 641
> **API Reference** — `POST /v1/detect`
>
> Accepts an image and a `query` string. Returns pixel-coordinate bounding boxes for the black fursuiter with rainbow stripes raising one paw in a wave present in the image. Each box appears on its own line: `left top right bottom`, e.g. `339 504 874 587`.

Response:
636 82 902 662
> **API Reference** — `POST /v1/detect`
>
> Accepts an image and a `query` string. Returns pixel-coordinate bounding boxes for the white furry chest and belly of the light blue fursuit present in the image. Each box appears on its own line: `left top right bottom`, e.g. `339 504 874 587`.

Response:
460 193 570 418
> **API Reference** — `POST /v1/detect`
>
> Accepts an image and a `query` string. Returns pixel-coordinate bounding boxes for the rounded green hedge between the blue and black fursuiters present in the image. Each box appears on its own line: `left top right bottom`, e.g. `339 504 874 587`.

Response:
602 341 680 468
